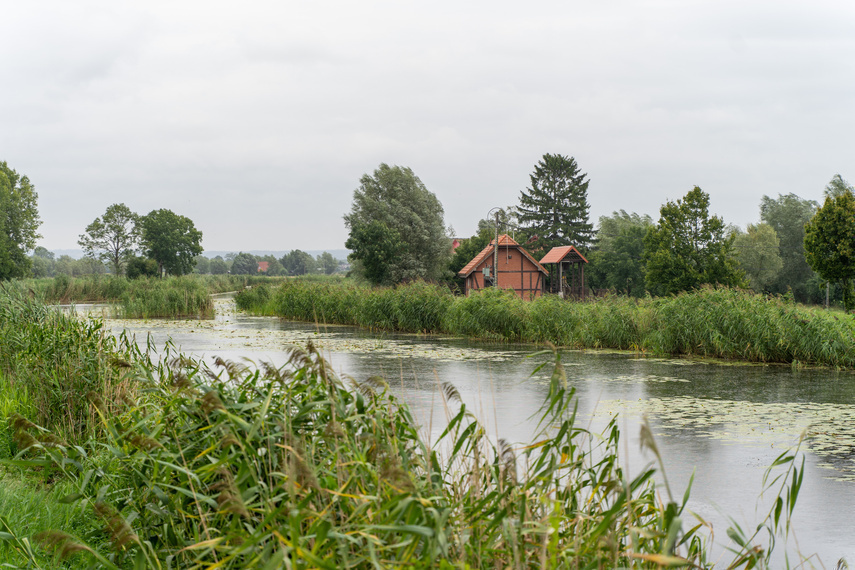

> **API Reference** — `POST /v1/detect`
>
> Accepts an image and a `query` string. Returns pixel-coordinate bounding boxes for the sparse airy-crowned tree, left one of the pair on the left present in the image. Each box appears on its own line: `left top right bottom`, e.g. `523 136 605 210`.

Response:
77 204 139 275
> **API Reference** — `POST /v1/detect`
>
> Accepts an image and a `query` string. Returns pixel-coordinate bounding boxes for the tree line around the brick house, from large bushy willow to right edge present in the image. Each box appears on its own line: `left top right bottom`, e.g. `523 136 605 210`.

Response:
344 154 855 310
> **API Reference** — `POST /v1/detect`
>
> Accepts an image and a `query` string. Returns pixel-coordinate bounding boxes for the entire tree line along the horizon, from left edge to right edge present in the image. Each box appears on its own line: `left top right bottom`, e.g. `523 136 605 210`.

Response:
0 154 855 310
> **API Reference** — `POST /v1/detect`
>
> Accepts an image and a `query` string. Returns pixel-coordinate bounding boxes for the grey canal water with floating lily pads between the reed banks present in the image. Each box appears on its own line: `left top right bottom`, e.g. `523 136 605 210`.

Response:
88 300 855 568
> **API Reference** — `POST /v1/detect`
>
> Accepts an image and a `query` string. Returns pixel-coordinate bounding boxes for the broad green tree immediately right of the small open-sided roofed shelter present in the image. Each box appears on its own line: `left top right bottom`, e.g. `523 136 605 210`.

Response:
585 210 653 297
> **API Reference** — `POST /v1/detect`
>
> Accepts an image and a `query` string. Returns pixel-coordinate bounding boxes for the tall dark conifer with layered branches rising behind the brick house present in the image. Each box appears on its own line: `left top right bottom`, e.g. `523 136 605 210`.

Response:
517 154 594 251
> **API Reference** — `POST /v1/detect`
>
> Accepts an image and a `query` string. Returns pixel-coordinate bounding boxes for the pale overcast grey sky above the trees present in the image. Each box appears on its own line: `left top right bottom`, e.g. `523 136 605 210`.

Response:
0 0 855 251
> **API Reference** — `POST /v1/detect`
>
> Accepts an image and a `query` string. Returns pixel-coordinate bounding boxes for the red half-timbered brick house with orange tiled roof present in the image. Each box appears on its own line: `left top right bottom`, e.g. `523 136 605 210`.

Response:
457 234 548 299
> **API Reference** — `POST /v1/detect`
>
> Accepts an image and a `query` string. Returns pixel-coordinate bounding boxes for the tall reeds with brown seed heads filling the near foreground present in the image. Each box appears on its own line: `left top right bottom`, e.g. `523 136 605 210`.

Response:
0 344 803 570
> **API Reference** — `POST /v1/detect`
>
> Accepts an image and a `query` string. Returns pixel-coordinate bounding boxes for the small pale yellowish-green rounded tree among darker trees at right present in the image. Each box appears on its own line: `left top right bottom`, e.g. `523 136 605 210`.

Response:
733 224 784 292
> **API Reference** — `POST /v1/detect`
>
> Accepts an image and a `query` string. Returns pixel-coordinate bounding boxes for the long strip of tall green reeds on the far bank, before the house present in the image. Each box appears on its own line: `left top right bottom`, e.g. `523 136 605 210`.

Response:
237 281 855 368
